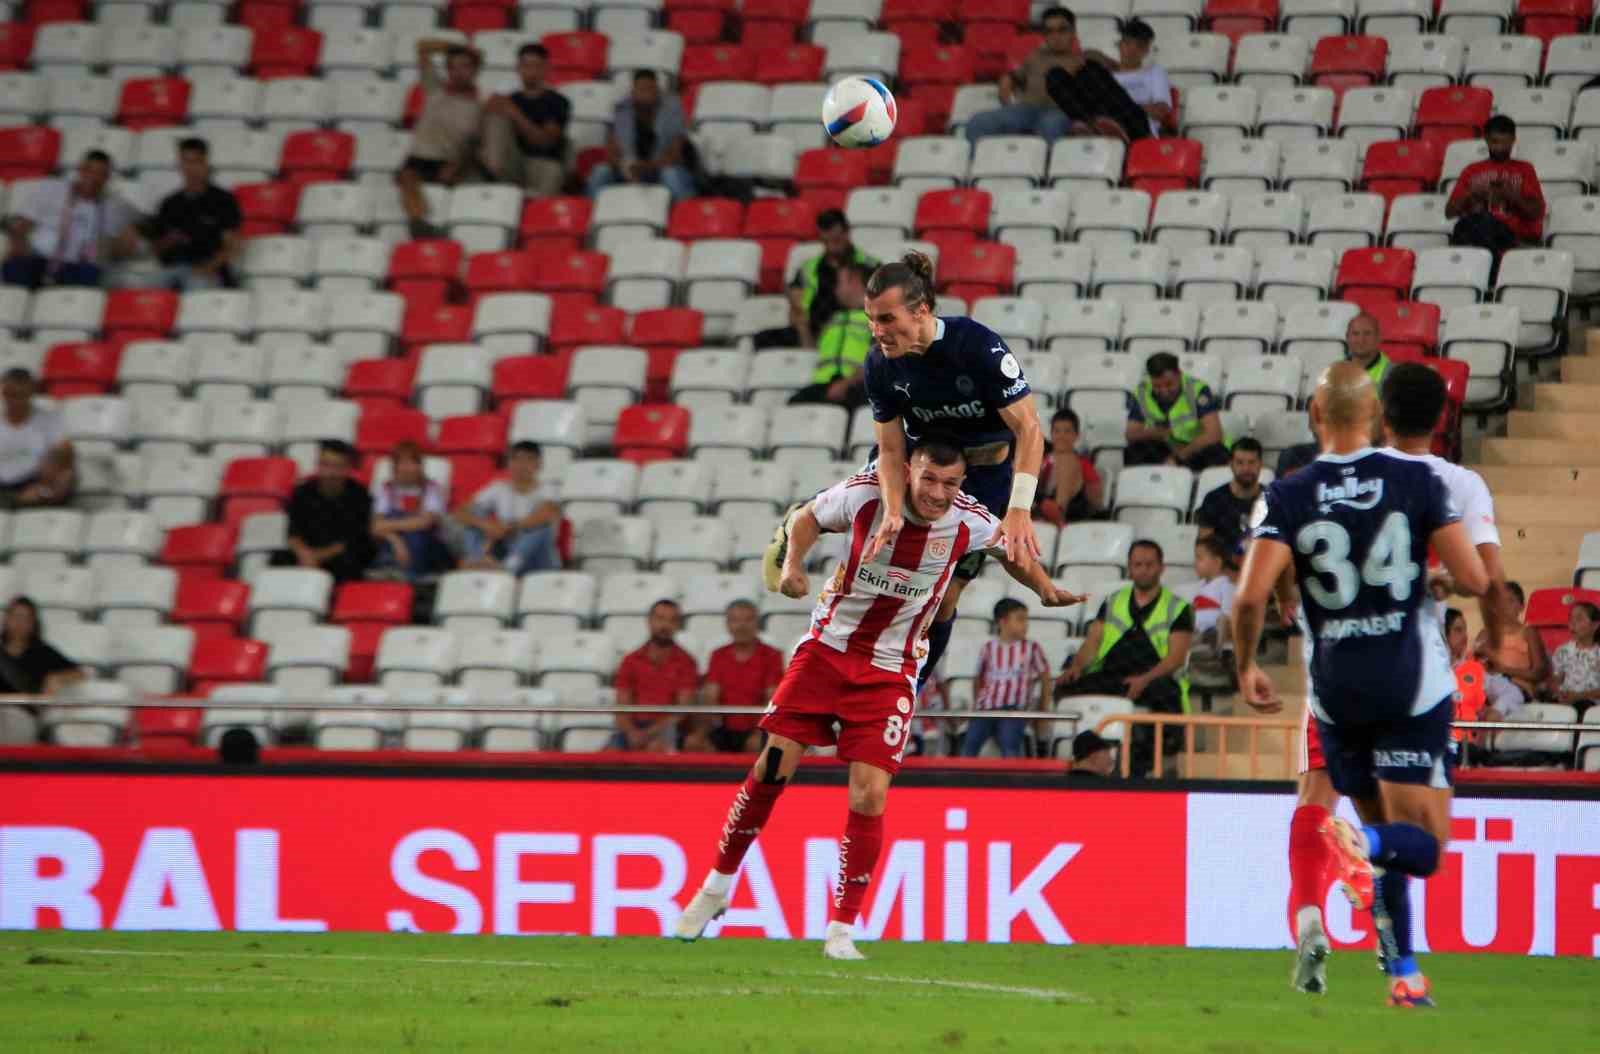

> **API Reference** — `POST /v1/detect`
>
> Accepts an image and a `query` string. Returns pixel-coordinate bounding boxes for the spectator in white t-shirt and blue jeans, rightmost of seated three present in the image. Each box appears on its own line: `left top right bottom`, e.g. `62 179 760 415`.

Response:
456 440 562 574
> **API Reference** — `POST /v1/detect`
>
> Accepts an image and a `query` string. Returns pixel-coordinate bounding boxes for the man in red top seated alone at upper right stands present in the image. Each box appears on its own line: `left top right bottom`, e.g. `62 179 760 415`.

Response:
1445 114 1544 267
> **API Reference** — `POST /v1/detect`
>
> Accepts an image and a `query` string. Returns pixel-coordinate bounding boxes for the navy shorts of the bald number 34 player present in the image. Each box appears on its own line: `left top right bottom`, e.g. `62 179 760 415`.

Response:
1317 696 1456 798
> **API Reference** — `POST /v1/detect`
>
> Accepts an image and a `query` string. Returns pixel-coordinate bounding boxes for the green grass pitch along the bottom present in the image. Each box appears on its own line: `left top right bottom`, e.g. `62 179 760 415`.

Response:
0 932 1600 1054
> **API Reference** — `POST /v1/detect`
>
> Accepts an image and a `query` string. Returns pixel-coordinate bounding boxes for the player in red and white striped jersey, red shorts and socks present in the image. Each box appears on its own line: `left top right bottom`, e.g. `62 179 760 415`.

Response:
675 435 1082 960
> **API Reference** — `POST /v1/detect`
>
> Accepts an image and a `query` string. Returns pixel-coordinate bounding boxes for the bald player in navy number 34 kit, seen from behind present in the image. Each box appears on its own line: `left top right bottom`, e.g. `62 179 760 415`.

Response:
1234 361 1490 1008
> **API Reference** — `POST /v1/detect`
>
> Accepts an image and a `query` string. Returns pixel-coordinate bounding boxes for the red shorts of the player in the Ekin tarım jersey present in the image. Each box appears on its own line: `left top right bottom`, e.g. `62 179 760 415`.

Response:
762 640 917 776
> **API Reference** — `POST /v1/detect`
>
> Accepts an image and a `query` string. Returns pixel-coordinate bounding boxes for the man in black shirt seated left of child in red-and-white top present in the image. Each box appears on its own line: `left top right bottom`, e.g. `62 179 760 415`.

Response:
272 440 378 582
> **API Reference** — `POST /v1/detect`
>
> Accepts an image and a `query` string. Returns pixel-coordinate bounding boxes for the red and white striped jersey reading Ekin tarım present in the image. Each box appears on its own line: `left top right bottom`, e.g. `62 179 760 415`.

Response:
811 472 1000 678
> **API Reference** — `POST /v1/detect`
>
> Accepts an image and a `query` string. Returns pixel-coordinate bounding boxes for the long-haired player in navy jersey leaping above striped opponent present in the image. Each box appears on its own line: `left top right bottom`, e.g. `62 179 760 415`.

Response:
766 253 1045 687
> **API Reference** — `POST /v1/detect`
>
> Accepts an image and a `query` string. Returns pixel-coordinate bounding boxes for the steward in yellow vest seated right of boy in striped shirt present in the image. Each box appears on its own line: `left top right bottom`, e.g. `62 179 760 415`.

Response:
1056 541 1195 776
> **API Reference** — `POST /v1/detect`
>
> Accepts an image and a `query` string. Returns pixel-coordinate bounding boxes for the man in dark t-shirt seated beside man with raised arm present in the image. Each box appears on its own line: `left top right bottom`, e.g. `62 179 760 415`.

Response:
483 43 573 197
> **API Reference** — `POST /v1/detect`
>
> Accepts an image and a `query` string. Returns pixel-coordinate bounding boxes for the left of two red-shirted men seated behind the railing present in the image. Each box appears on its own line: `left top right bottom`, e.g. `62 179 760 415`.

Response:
611 600 710 753
